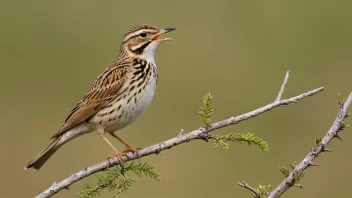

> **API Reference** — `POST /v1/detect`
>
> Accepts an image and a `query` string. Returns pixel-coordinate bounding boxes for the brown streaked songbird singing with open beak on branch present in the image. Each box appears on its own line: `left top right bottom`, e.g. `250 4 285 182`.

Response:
25 24 175 170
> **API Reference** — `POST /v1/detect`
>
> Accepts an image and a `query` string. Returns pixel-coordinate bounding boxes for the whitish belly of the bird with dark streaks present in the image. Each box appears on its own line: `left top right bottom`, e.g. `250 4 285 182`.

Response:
90 79 156 132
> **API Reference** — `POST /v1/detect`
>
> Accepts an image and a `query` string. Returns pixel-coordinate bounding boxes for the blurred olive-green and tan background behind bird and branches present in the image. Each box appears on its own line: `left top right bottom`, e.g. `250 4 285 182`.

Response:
0 0 352 198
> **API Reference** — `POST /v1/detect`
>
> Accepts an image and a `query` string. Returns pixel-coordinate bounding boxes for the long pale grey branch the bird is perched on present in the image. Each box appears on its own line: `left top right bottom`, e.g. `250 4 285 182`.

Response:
37 73 324 198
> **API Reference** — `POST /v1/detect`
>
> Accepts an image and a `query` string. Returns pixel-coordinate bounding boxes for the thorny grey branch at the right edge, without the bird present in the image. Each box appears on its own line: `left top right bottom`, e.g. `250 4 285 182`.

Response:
267 92 352 198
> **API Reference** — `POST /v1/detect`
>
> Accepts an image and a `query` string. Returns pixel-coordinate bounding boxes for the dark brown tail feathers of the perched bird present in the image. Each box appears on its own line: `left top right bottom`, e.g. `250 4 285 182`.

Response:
24 136 61 170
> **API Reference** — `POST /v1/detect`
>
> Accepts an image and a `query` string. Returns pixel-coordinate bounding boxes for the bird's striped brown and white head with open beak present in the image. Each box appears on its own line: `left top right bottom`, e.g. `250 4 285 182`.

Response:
121 25 175 58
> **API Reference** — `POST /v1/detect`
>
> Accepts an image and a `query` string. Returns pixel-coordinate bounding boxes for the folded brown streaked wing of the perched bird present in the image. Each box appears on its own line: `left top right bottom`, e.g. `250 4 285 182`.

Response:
52 66 128 138
